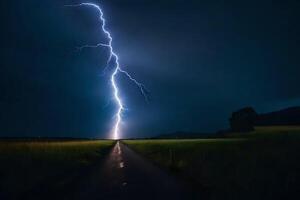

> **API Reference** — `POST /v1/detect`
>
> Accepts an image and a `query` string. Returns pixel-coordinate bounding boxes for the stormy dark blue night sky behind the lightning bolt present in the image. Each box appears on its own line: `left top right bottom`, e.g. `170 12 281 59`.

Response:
0 0 300 137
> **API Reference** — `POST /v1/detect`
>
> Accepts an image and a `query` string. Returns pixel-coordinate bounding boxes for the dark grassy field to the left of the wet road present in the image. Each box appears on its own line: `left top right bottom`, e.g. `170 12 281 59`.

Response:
0 140 114 199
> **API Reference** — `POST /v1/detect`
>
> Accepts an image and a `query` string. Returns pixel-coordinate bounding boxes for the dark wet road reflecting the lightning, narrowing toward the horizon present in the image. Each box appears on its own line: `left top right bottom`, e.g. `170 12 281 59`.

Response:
71 142 199 200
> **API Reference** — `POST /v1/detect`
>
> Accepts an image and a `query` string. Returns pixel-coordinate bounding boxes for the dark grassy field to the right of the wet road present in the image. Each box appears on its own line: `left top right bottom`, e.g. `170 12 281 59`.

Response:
123 127 300 199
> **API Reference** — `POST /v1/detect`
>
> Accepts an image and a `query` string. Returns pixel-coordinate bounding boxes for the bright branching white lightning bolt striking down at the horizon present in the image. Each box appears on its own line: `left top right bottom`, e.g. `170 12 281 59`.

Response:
65 2 148 139
